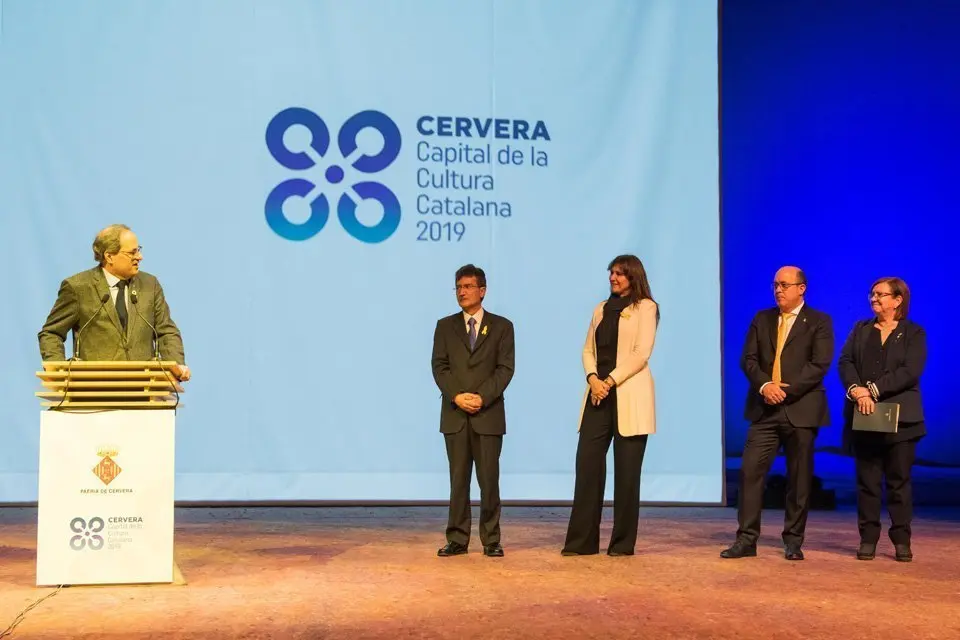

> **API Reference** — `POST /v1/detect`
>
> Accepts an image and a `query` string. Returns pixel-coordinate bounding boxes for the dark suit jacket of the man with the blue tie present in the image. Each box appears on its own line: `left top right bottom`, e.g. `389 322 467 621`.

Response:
431 309 514 435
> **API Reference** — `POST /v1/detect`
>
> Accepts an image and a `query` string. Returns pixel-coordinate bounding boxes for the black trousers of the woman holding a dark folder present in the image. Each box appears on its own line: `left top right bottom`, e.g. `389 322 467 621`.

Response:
853 434 917 544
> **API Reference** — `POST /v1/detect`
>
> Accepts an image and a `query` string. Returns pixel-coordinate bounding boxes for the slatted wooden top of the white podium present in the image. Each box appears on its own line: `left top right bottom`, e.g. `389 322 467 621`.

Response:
34 360 184 411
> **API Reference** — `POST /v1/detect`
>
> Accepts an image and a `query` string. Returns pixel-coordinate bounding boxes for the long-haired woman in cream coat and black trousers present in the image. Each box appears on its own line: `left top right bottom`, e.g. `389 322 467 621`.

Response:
561 255 660 556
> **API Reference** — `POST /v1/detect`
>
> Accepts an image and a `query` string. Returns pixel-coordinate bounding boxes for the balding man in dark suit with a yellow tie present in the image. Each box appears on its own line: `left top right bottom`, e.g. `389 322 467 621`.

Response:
720 267 834 560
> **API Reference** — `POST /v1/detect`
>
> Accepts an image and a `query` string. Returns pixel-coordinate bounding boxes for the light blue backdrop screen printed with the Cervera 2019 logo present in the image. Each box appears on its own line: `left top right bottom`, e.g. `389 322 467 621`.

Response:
0 0 723 502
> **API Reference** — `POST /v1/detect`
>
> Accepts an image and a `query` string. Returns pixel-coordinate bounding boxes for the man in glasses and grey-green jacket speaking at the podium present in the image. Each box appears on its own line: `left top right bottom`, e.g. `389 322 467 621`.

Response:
38 224 190 381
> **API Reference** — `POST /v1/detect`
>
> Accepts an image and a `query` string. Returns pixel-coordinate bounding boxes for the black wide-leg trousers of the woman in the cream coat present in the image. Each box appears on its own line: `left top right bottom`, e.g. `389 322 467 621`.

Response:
563 389 647 555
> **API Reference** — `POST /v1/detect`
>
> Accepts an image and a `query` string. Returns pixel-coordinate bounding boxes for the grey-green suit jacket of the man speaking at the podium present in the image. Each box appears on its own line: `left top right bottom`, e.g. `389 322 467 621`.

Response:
37 266 184 364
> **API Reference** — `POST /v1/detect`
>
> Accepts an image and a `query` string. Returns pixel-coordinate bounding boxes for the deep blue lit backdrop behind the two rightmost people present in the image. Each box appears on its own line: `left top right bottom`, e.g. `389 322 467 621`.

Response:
721 0 960 475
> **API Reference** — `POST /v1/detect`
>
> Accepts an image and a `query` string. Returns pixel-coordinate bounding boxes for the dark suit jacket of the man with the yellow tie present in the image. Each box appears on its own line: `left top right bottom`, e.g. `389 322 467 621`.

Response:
740 303 834 427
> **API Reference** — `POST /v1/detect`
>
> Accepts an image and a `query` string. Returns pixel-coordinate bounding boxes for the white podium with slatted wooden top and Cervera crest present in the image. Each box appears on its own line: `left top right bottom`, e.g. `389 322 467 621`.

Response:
35 360 184 586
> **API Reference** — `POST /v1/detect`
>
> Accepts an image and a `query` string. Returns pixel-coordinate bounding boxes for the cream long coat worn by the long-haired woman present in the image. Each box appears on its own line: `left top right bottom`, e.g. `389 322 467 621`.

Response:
577 300 657 436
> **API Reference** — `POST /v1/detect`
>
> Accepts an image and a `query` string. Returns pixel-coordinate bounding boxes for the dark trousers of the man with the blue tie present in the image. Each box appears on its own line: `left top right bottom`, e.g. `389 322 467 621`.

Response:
443 425 503 546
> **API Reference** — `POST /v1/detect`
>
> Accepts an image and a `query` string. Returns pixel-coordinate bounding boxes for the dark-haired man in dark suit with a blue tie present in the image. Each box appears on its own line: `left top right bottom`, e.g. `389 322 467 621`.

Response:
431 264 514 557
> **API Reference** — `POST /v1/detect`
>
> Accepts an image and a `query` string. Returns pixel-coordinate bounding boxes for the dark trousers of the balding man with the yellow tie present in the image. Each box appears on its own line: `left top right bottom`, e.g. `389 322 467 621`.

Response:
737 406 817 545
